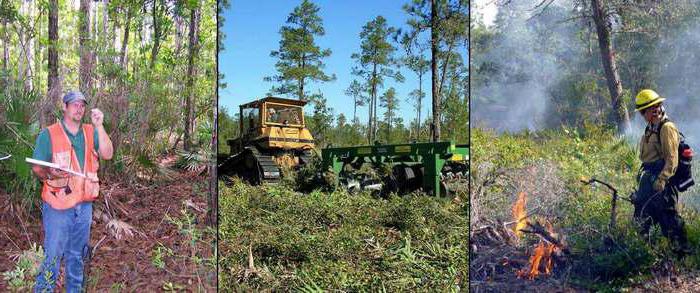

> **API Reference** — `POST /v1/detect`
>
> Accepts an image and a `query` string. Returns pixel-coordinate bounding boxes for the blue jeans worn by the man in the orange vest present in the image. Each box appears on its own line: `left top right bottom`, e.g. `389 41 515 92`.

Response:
34 202 92 293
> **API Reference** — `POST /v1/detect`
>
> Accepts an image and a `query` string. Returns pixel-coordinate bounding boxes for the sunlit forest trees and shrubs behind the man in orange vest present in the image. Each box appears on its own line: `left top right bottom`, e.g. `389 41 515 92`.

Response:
0 0 216 204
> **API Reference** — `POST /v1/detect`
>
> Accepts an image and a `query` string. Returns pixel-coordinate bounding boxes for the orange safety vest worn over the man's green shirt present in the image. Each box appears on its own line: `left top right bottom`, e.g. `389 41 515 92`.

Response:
41 122 100 210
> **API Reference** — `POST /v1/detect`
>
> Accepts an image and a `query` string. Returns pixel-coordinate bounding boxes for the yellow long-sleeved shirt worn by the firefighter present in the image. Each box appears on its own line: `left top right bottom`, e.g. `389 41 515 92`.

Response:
639 120 680 181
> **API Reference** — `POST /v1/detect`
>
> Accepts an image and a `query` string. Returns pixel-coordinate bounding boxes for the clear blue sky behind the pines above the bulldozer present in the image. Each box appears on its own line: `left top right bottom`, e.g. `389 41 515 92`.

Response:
219 0 431 124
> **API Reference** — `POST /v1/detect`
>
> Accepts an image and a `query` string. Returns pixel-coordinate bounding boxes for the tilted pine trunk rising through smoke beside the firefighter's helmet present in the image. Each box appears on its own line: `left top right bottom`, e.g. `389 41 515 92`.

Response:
591 0 630 133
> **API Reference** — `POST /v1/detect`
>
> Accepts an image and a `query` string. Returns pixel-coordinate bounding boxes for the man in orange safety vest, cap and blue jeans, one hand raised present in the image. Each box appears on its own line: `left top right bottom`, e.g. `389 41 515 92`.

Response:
32 91 114 292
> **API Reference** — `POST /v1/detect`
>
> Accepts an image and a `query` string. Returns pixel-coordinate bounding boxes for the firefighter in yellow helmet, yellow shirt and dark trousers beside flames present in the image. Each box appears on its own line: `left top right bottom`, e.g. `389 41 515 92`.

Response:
634 89 690 257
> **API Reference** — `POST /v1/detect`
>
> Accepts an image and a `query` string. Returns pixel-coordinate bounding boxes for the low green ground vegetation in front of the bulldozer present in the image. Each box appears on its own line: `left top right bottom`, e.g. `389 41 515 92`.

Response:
219 181 469 292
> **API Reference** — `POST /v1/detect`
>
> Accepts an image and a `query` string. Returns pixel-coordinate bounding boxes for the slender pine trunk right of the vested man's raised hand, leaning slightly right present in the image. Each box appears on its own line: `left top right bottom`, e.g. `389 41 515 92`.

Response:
184 7 199 151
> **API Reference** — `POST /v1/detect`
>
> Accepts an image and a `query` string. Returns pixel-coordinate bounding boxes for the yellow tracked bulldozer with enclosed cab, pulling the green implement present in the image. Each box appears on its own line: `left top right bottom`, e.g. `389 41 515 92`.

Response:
218 97 314 184
